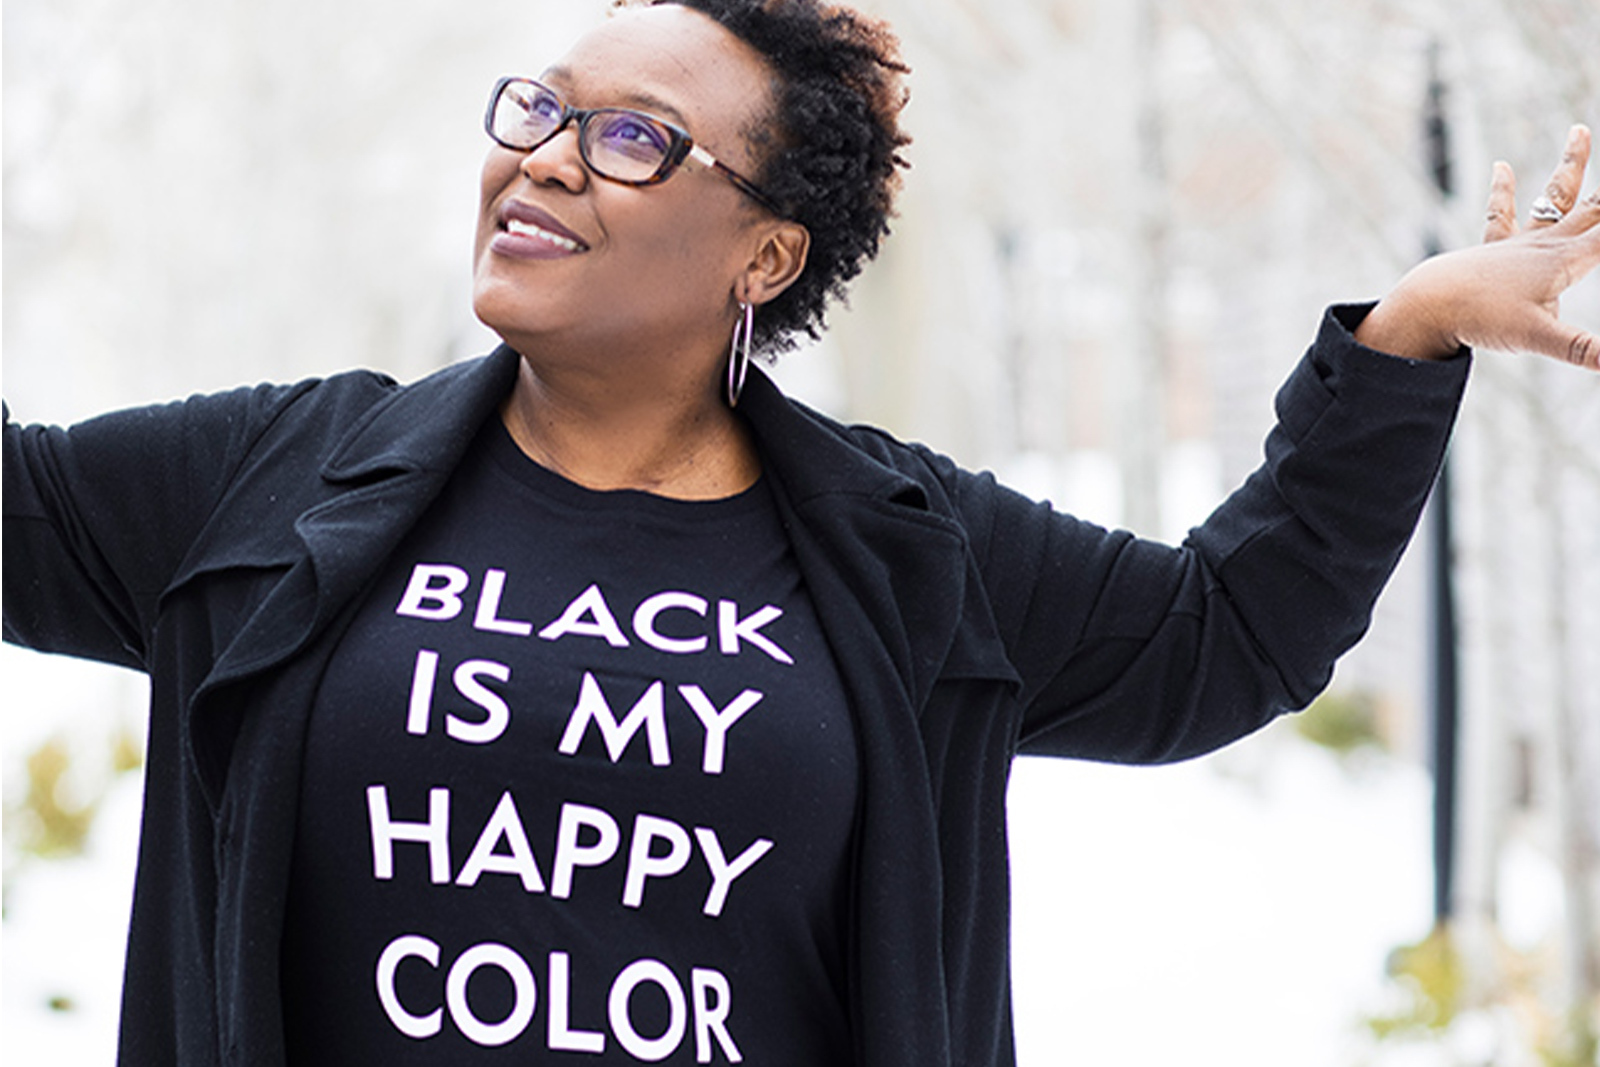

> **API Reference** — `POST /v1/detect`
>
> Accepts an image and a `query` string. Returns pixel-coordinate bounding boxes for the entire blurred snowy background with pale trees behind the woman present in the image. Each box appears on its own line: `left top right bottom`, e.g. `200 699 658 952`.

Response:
0 0 1600 1067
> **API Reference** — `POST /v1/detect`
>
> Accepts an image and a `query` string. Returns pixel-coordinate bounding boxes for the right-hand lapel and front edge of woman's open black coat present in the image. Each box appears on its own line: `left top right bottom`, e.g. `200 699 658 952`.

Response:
744 373 1016 1067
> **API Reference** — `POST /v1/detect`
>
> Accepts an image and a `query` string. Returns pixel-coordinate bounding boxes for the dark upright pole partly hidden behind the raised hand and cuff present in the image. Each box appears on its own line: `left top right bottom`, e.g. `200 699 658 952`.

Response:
1422 40 1459 923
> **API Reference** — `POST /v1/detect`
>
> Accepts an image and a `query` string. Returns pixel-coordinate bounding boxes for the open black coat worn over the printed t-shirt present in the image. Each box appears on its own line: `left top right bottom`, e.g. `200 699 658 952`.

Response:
5 309 1467 1067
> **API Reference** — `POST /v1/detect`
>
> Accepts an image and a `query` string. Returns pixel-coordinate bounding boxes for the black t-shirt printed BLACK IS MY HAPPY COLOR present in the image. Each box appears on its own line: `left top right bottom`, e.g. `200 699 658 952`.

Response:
283 421 858 1067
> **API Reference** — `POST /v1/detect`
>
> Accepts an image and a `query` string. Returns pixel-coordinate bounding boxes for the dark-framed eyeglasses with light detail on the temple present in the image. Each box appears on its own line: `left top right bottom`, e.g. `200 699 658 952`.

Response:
483 78 782 214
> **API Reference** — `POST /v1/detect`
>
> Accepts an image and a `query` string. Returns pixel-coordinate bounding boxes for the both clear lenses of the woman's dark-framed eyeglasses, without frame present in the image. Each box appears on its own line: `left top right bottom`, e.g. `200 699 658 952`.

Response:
490 82 674 182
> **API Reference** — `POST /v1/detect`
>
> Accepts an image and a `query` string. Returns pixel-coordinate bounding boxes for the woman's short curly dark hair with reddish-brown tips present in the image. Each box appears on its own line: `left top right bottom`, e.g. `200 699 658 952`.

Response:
619 0 910 355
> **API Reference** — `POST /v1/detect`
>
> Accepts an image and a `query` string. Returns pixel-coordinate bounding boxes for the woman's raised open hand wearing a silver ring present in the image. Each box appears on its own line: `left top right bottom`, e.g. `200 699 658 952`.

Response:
1355 126 1600 371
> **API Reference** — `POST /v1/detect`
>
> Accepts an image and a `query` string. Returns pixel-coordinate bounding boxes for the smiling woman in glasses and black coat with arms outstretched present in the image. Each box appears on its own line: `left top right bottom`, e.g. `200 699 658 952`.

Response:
5 0 1600 1067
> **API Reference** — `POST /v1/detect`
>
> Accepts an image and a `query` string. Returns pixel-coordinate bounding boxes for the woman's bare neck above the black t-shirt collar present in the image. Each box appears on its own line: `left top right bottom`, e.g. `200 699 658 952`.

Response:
501 351 760 499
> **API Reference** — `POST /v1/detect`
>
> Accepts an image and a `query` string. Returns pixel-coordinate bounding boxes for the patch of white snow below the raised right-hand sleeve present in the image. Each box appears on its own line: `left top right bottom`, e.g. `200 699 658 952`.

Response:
1011 739 1432 1067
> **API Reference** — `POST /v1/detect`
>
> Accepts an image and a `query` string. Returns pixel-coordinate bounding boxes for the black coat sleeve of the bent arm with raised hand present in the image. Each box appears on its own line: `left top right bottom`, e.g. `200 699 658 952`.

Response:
957 307 1470 763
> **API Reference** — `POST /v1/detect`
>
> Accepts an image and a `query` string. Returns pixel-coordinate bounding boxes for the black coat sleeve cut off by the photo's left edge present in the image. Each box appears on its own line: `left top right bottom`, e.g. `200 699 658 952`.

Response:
3 386 315 669
